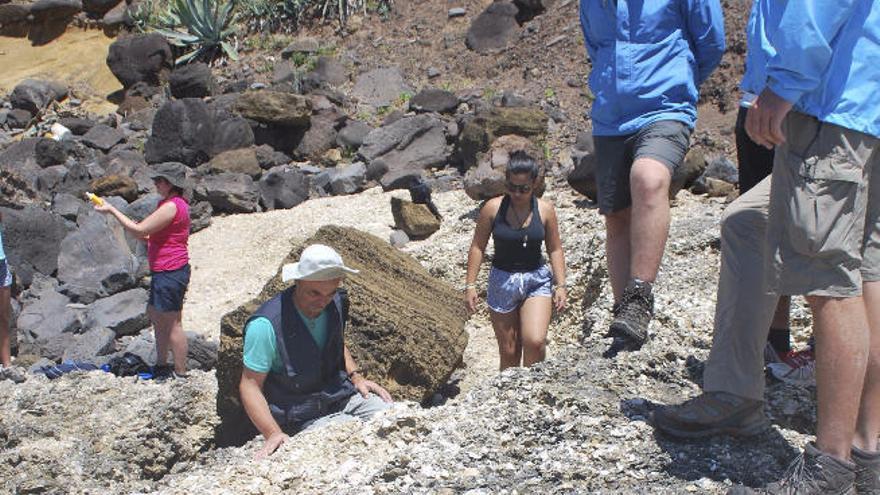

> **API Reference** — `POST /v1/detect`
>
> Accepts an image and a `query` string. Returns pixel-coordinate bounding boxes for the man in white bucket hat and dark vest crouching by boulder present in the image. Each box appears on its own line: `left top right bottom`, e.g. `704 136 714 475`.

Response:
239 244 391 458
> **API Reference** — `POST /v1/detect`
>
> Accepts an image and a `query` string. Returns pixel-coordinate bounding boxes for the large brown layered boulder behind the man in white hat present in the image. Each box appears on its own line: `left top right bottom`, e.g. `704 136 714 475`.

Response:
217 226 468 445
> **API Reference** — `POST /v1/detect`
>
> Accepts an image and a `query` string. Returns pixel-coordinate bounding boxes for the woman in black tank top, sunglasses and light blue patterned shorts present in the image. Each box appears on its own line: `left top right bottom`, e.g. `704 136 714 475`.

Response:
464 151 566 370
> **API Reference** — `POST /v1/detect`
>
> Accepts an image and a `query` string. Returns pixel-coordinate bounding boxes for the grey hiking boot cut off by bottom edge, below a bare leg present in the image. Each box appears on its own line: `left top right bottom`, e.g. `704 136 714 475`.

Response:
727 443 861 495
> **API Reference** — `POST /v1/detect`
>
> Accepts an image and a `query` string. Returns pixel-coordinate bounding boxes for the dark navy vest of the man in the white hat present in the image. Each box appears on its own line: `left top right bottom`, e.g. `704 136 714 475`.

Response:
248 287 356 427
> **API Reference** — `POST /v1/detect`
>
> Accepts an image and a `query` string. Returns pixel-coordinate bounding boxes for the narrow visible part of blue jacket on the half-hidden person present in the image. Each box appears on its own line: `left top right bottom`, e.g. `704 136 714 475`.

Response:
739 0 788 94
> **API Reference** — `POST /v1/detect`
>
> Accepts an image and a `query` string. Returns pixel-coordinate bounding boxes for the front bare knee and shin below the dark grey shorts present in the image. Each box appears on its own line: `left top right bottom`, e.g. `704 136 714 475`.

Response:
628 158 672 282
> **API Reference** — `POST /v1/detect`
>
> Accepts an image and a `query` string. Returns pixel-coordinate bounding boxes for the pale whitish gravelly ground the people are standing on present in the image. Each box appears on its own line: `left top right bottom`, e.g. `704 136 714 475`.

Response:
0 181 814 494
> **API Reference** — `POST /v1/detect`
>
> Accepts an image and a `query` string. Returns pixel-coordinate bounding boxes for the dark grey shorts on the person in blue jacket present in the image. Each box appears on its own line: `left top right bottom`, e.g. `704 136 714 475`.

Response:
593 120 691 215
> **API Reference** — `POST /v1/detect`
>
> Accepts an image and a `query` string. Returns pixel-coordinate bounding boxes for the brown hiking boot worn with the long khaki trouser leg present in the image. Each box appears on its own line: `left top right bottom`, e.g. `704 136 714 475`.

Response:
653 392 768 438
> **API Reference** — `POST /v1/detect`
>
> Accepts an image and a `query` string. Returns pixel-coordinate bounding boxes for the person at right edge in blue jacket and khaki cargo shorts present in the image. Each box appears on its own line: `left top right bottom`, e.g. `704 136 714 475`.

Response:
746 0 880 494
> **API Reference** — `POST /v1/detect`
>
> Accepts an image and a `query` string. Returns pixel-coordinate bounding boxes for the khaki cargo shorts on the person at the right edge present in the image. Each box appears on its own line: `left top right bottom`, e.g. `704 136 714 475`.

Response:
765 111 880 297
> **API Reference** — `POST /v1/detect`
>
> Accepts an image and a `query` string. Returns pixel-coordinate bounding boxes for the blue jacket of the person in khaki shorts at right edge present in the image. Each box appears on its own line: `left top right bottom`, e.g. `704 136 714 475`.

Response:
767 0 880 137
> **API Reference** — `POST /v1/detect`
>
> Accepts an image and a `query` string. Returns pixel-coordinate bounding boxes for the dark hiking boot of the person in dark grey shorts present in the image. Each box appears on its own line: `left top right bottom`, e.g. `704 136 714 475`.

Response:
608 278 654 350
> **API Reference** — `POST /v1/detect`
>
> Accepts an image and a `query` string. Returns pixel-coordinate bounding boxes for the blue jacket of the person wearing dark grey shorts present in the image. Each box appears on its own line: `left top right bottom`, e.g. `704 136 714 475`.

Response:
580 0 724 136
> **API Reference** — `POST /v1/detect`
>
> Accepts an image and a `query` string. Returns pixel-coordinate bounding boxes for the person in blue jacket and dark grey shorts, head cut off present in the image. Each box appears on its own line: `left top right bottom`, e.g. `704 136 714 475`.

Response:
580 0 724 349
